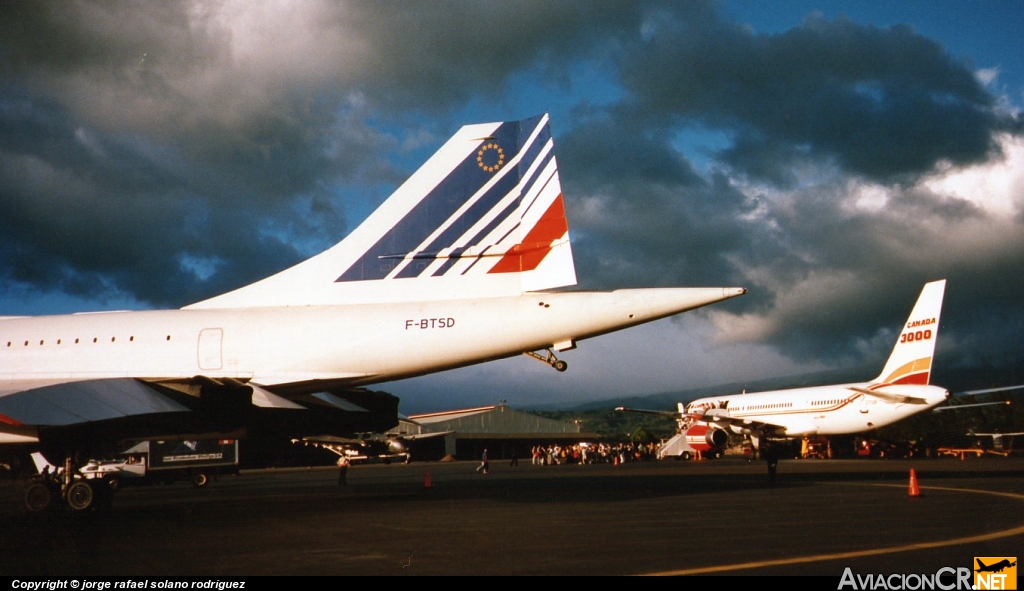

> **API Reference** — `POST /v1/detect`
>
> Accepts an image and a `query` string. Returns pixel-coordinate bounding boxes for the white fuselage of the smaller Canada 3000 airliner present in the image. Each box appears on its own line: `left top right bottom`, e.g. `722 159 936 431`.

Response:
686 382 949 437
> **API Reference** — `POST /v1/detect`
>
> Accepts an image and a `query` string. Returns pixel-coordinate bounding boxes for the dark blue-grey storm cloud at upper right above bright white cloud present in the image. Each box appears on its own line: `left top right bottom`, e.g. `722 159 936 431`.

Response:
621 12 1016 183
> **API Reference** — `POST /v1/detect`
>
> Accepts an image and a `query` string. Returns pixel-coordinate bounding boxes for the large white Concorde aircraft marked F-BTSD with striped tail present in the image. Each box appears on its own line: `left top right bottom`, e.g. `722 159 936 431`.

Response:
0 115 745 508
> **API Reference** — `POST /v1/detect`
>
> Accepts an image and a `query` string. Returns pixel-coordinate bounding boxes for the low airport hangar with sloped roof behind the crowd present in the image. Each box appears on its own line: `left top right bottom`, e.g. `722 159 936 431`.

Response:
388 404 598 461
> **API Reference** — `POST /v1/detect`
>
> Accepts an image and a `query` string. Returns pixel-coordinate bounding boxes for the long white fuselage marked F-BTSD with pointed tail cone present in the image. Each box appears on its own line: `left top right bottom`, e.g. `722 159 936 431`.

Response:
0 288 743 395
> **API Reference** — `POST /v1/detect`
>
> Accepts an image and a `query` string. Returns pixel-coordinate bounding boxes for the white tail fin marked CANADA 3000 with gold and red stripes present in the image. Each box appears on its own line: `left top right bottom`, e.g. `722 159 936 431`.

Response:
874 280 946 385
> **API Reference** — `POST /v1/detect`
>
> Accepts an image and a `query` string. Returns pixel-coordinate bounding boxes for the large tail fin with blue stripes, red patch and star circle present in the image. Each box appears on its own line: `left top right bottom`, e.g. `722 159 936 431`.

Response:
187 115 575 308
